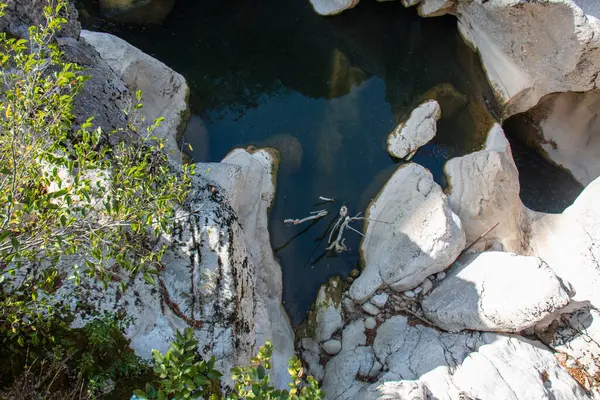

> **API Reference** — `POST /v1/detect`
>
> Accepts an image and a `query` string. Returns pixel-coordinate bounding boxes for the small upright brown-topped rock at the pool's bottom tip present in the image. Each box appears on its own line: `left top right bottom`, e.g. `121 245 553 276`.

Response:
313 277 344 342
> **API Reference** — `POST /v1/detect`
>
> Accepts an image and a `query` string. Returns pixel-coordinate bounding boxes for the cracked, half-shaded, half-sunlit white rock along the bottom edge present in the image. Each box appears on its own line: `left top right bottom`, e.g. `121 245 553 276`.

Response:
324 316 591 400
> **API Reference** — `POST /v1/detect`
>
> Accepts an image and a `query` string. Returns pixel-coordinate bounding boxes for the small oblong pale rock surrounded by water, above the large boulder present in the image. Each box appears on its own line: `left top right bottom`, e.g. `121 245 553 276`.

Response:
387 100 442 158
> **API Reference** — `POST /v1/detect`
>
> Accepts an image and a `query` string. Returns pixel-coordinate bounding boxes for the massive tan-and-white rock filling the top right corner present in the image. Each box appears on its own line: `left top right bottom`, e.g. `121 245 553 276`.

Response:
457 0 600 117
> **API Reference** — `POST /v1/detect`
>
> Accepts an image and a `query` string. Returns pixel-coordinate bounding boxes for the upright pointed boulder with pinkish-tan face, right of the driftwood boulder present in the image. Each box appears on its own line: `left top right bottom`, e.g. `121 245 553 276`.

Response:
445 124 529 254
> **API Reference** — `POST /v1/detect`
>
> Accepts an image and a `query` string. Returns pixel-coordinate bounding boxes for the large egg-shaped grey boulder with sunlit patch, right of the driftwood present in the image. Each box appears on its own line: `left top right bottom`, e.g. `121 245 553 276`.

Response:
349 164 465 303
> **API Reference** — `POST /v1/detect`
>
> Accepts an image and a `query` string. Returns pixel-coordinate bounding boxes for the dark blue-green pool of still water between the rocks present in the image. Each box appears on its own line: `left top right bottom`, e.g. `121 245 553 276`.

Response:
78 0 576 324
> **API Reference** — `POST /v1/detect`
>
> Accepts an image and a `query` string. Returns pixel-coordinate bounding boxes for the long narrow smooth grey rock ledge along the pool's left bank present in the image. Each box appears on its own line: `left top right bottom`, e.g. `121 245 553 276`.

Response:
220 149 294 388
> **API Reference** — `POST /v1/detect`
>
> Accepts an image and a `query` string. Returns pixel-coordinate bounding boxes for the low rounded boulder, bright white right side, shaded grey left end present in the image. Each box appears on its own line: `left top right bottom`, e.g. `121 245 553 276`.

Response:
422 252 569 332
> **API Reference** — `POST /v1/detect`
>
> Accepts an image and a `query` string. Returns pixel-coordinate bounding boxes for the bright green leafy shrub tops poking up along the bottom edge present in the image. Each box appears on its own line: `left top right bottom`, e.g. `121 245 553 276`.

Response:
134 329 324 400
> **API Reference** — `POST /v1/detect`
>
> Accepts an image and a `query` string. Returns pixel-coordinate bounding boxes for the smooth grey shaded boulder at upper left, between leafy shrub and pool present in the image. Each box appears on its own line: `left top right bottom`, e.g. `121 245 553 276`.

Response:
81 30 189 164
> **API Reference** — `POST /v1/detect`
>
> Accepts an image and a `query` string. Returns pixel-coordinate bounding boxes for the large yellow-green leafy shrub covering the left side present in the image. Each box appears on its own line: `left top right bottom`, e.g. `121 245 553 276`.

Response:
0 0 194 391
